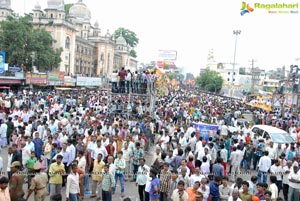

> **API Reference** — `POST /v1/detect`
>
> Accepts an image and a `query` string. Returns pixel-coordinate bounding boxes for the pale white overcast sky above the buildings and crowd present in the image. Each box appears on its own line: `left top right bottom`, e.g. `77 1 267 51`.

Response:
11 0 300 74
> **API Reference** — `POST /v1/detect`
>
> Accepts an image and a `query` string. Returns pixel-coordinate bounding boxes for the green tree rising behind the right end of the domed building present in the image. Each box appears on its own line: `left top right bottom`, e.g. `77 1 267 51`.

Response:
113 27 139 58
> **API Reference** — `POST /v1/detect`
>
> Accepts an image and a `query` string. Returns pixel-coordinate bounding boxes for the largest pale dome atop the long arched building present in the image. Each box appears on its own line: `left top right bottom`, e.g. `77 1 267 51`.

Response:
69 0 91 22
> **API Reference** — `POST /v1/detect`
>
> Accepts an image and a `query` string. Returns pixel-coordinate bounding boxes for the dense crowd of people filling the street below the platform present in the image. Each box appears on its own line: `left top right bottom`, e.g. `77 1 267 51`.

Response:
0 82 300 201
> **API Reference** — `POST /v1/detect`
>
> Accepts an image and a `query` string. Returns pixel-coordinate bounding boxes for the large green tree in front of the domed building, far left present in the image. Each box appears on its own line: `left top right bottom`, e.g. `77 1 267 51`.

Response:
0 15 62 71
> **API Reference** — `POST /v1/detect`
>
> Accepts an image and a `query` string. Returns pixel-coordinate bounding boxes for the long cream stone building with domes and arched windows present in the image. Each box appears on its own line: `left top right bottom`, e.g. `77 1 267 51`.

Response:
0 0 137 77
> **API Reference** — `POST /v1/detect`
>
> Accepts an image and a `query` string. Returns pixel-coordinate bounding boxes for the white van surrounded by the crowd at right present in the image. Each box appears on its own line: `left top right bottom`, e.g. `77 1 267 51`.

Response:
251 125 296 144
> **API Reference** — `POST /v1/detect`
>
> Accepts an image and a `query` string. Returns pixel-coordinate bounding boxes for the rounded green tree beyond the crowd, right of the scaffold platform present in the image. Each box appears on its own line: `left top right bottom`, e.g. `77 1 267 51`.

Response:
196 69 223 92
